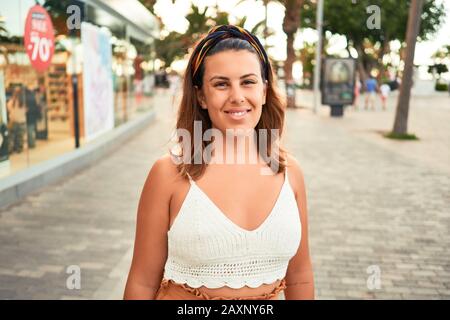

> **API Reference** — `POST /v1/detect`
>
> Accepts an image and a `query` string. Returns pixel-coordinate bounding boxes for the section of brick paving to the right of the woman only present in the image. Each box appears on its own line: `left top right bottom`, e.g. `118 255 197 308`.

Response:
288 92 450 299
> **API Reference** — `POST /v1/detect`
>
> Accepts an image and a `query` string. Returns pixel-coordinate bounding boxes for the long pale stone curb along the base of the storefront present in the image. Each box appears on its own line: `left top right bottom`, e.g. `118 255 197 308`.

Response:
0 110 155 209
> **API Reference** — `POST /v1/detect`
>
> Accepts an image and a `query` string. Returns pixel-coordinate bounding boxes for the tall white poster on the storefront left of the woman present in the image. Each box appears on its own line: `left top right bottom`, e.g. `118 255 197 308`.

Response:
81 22 114 140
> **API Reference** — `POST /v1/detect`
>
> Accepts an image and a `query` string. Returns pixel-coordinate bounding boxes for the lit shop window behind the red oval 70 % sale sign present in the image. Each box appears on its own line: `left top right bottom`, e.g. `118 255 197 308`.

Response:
0 0 73 176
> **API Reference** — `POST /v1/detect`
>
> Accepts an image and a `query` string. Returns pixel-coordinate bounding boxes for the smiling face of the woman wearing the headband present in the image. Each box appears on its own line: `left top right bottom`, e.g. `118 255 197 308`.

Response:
197 50 267 133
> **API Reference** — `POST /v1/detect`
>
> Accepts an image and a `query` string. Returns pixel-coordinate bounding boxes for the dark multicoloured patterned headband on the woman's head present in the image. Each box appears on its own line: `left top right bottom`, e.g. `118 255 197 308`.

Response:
192 25 269 79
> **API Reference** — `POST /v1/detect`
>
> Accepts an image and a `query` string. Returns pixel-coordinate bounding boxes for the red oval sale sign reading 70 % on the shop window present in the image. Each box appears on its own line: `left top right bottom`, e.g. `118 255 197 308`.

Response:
24 5 55 71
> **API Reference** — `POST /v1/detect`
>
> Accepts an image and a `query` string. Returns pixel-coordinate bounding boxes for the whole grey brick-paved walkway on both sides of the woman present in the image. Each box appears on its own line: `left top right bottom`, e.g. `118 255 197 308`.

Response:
0 90 450 299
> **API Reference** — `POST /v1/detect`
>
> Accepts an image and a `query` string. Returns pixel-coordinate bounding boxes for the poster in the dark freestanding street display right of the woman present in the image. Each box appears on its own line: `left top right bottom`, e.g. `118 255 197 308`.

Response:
322 58 356 106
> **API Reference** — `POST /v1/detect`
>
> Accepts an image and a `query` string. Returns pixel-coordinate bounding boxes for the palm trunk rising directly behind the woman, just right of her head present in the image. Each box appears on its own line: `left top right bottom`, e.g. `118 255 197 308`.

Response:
283 0 303 108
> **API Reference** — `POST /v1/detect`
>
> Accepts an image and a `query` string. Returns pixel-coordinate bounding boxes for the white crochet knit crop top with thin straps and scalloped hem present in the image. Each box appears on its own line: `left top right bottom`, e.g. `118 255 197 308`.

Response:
164 169 301 289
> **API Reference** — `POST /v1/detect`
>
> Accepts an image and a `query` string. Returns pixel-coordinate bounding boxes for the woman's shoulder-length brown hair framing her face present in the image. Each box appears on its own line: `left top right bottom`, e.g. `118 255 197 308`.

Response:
169 26 287 180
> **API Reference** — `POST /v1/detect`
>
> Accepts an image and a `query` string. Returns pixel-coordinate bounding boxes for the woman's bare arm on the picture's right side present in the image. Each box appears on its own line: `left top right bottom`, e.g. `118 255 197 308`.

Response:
284 157 314 300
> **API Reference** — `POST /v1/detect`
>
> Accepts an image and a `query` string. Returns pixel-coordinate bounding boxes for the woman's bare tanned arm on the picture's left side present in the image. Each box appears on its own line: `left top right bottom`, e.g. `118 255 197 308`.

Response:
124 157 173 299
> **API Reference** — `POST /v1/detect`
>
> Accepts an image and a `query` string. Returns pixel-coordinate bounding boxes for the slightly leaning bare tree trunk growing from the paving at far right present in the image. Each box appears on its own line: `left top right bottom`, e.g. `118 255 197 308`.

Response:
392 0 423 134
